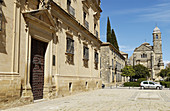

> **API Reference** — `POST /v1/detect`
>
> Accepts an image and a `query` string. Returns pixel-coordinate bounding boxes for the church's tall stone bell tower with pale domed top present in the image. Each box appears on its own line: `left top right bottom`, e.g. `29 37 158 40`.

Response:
152 26 164 74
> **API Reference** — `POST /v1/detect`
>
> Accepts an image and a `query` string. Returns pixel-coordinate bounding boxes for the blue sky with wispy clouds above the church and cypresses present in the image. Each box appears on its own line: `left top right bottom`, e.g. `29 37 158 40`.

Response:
100 0 170 64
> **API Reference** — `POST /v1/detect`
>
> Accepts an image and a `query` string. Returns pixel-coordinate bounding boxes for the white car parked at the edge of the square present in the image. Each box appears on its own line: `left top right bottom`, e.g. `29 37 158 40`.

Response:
140 81 162 90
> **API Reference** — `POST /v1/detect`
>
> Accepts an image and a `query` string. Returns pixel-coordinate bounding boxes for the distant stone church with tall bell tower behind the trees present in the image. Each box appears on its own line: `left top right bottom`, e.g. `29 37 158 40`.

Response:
129 26 164 79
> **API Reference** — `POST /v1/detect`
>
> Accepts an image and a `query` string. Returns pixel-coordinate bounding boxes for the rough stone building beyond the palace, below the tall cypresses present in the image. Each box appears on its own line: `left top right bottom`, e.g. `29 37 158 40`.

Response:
100 42 126 85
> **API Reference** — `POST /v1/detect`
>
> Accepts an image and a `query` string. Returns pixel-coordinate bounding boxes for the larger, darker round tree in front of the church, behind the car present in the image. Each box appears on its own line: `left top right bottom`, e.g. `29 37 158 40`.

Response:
134 64 150 79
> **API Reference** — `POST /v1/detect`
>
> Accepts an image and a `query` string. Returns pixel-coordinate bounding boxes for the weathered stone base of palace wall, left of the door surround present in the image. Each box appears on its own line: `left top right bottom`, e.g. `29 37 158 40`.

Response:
0 75 22 109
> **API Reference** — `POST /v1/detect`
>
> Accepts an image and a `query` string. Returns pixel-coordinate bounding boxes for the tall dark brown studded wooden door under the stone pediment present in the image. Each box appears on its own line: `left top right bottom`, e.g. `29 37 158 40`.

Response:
30 39 47 100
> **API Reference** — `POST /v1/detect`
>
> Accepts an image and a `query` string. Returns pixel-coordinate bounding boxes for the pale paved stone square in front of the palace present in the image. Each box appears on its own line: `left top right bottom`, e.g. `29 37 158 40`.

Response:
2 88 170 111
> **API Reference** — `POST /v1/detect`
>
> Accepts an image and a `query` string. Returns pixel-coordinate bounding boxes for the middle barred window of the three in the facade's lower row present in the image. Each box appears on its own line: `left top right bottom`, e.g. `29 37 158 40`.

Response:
83 45 89 68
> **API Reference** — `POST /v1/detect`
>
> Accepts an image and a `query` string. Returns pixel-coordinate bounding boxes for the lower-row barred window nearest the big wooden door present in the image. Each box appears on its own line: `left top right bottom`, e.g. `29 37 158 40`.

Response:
66 37 74 64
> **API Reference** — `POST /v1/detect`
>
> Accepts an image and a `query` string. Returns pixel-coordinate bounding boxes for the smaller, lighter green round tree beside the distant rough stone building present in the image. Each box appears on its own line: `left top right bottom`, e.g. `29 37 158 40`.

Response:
121 66 135 77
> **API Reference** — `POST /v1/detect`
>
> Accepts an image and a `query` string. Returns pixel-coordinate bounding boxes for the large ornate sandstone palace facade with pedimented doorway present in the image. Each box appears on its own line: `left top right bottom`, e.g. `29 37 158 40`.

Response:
0 0 102 108
